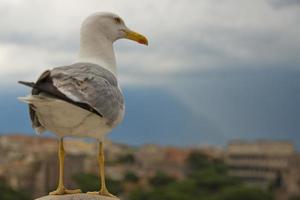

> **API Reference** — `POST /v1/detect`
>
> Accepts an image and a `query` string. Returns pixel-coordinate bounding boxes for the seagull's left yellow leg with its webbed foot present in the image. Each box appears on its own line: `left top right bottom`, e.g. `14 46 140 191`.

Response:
49 138 81 195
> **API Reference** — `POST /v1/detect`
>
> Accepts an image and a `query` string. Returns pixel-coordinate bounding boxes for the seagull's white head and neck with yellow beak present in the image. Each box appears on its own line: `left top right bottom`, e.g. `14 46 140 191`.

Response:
79 12 148 74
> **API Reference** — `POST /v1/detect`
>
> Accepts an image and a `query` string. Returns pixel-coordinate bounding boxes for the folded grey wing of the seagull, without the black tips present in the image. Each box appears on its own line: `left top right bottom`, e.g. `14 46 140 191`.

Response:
50 63 124 125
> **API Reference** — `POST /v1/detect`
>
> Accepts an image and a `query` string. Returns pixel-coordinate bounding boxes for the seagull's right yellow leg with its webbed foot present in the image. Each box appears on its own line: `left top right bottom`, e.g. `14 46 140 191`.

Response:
88 142 115 197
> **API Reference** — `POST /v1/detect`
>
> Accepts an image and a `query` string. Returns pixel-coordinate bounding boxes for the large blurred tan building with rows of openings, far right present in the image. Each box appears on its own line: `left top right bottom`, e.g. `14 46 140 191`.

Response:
225 140 300 199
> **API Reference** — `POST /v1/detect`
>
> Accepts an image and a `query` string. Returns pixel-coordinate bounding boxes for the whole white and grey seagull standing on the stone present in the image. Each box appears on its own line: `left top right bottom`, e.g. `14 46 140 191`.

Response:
19 12 148 197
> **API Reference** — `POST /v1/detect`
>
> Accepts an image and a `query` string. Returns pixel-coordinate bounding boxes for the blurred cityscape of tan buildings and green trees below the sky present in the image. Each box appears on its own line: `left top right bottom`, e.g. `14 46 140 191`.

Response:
0 134 300 200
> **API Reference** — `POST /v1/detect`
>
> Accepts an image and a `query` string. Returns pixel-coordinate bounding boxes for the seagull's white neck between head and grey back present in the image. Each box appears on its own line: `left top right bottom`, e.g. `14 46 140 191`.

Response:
78 33 117 76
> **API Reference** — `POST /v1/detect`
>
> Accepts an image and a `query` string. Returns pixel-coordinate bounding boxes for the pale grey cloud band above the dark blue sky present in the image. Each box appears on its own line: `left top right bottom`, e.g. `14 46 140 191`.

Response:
0 0 300 82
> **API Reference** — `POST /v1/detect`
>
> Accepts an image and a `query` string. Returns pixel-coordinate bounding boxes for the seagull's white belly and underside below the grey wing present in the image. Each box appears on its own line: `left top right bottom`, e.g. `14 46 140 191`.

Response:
21 97 123 140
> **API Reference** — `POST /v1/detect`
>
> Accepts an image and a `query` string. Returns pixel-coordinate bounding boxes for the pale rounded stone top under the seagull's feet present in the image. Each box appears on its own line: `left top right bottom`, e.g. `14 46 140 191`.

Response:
35 194 120 200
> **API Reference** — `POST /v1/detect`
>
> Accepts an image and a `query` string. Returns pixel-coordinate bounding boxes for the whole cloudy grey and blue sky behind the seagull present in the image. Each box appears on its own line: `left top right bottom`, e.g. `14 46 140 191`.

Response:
0 0 300 148
